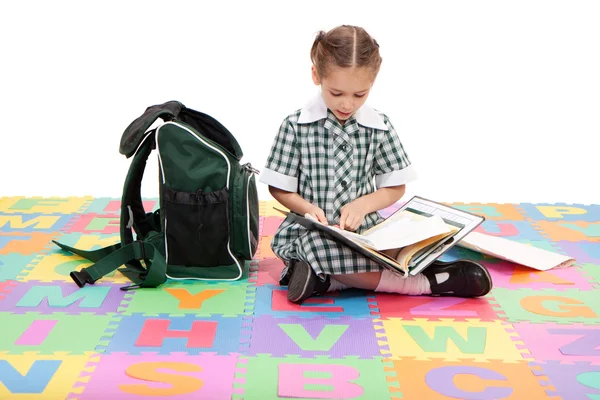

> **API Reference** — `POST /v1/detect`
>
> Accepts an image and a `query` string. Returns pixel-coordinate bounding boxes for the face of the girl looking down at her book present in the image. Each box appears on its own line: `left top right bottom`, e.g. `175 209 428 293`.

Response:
312 65 374 124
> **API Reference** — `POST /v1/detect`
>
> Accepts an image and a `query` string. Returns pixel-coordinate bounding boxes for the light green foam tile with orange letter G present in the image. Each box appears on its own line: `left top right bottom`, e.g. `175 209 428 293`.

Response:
494 288 600 324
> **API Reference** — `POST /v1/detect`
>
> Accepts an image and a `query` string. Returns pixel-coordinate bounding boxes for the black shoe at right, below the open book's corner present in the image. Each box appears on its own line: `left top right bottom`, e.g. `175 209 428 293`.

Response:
423 259 492 297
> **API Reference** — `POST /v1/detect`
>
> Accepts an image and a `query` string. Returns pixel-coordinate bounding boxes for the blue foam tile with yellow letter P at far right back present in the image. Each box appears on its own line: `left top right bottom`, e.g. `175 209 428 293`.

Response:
519 203 600 222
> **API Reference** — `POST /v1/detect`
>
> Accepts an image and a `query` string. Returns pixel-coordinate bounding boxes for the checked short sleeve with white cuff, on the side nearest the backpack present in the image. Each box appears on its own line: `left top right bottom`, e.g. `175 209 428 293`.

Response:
259 117 300 192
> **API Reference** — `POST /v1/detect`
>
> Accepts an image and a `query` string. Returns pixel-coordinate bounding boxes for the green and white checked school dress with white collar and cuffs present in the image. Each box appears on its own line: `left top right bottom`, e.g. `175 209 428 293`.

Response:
259 92 416 278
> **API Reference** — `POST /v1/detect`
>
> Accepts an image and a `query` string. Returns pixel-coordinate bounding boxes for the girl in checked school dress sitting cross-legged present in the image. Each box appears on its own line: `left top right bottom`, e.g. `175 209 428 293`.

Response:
260 25 492 303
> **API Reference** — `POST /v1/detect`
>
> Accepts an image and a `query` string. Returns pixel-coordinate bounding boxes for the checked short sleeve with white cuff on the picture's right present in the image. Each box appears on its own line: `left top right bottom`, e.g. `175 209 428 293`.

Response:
374 116 417 188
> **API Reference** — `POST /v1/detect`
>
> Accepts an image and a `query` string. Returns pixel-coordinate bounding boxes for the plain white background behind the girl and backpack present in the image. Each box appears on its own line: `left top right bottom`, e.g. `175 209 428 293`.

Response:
0 0 600 204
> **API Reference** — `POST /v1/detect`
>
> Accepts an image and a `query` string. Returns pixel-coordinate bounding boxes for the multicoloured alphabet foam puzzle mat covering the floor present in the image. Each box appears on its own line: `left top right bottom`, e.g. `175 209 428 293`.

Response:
0 197 600 400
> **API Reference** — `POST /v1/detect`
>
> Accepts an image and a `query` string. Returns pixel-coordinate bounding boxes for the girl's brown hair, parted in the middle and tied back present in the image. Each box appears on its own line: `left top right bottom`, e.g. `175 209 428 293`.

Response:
310 25 381 77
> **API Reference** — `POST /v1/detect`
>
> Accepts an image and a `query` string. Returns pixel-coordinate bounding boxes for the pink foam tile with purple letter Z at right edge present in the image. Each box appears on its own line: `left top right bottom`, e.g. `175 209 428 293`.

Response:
513 322 600 365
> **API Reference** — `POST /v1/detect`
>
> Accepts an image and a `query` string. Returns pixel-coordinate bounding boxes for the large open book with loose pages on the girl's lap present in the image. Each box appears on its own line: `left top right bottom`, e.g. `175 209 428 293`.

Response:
276 196 484 275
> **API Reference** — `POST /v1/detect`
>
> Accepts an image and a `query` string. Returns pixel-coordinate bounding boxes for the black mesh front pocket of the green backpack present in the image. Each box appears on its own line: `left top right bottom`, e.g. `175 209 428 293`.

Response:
162 185 233 267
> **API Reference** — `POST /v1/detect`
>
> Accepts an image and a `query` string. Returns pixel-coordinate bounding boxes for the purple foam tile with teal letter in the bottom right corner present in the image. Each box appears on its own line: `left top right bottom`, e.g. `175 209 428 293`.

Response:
532 361 600 400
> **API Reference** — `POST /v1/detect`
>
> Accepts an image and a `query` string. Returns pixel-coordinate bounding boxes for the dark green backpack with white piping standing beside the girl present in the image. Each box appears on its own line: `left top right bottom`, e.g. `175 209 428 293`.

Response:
54 101 259 290
